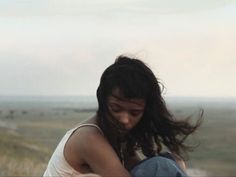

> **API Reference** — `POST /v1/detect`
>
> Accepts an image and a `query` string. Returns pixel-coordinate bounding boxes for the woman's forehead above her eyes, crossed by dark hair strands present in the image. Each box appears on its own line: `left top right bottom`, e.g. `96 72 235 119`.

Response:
108 89 145 107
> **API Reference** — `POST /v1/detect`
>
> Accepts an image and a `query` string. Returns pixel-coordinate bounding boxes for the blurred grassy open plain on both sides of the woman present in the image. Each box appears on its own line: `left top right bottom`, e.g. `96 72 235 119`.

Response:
0 97 236 176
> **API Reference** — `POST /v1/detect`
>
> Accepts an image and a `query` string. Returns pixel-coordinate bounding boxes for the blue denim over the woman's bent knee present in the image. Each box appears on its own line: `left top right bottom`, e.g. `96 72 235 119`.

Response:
131 156 187 177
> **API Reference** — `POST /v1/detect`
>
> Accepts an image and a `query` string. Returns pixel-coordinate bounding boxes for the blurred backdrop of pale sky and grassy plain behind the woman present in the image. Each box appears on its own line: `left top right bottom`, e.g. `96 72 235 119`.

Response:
0 0 236 176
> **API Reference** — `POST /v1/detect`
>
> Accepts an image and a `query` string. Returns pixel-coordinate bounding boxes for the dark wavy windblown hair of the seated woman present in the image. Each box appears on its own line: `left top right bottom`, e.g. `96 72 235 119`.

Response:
97 55 202 162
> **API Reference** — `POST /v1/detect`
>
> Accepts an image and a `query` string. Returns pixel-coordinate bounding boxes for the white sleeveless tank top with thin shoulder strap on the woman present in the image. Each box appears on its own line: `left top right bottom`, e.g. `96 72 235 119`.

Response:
43 124 103 177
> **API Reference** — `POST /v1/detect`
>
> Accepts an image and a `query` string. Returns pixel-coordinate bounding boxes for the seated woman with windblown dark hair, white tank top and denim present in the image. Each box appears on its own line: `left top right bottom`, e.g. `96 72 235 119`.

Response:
44 56 202 177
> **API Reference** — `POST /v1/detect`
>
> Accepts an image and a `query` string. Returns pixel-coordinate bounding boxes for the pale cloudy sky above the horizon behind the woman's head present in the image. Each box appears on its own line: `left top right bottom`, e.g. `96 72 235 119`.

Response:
0 0 236 97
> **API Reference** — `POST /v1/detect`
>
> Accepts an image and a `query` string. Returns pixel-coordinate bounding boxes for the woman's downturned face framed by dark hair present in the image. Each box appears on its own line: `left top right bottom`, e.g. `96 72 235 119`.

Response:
107 89 145 136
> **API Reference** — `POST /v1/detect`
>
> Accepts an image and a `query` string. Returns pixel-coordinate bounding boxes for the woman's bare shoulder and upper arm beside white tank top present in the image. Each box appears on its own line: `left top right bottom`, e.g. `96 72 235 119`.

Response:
67 128 130 177
